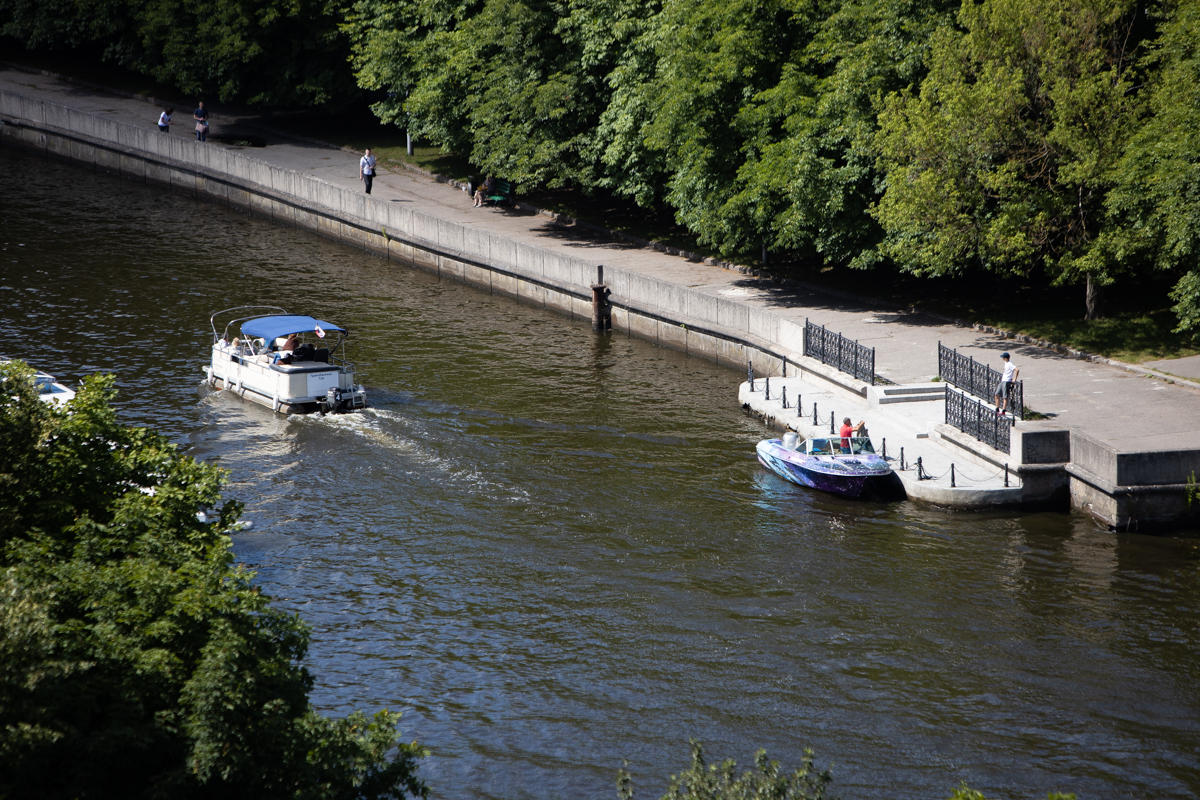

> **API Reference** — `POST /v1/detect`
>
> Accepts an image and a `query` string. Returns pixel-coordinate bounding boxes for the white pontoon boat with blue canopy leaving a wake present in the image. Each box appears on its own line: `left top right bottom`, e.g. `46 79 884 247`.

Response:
205 306 367 414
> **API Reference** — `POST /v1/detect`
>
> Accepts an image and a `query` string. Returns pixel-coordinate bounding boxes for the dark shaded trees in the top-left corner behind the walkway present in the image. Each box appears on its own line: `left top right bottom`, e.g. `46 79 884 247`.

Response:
0 0 356 106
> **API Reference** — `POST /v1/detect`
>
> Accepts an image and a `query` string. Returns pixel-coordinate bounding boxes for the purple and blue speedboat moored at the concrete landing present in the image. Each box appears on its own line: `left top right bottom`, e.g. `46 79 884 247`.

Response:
758 432 892 498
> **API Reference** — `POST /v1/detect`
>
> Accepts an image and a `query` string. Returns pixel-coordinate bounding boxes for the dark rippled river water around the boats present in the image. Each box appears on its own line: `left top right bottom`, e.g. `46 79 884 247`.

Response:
7 150 1200 799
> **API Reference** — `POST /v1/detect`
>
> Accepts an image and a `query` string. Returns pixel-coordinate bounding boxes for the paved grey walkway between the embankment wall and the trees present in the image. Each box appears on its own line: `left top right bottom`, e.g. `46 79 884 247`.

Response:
0 67 1200 460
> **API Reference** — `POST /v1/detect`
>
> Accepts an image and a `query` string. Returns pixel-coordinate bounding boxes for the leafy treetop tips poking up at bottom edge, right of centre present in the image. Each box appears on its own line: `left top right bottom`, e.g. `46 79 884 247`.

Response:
617 739 833 800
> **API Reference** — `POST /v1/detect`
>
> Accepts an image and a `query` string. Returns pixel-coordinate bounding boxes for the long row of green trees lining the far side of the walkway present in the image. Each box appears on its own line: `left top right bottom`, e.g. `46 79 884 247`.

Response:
7 0 1200 336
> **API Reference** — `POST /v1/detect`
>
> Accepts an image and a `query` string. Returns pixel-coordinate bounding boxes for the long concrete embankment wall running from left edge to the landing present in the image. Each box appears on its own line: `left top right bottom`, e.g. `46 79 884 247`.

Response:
0 91 803 374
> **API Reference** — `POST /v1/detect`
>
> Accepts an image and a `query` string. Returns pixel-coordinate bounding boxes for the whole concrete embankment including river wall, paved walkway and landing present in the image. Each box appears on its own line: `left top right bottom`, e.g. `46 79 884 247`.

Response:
0 68 1200 530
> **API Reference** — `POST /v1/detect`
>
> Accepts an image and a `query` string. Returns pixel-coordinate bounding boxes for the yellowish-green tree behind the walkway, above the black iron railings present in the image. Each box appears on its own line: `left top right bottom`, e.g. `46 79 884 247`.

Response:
876 0 1152 319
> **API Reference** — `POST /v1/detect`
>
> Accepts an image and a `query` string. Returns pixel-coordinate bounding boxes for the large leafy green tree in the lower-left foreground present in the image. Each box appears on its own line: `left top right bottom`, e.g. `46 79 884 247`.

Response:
0 363 425 799
